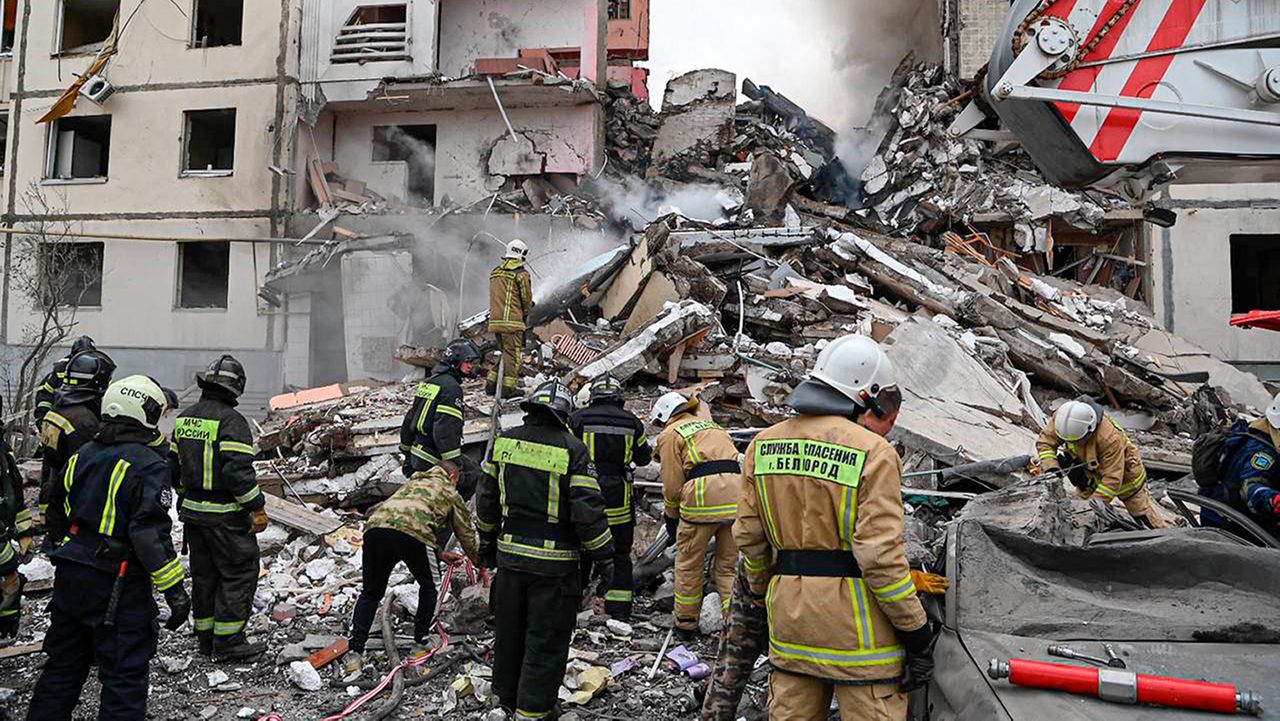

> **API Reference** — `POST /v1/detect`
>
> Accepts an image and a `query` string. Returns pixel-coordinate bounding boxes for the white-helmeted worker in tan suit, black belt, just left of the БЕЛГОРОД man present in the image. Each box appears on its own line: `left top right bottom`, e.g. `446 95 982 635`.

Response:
650 391 742 640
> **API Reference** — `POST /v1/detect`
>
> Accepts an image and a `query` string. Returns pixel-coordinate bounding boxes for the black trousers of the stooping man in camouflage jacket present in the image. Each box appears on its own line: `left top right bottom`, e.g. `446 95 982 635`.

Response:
351 528 435 653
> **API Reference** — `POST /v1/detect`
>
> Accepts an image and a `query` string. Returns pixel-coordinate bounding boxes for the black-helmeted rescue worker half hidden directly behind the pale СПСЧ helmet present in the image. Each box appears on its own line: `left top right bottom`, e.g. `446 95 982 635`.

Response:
38 350 115 542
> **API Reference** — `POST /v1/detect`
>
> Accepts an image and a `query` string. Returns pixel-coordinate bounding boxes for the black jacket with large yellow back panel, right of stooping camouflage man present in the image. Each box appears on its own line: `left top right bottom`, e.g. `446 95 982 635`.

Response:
476 415 613 576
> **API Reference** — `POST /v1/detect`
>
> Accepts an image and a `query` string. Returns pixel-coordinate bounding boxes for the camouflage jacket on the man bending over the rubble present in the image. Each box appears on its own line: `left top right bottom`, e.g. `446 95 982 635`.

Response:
366 466 480 563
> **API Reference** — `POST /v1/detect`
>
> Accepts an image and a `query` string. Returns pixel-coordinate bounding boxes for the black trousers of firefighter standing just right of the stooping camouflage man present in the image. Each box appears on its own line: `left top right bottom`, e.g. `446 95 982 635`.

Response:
489 569 582 718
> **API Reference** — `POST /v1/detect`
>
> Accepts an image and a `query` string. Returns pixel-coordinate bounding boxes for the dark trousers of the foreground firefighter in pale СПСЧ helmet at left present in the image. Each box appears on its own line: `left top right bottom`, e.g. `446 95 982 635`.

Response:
27 561 159 721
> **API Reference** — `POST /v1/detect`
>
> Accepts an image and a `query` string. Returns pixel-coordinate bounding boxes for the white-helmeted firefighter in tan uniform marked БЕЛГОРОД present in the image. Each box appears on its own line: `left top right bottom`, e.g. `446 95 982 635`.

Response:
733 336 933 721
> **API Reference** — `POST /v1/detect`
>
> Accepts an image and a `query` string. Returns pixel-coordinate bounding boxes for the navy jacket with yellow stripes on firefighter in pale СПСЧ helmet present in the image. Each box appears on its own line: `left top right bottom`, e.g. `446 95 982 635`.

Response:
50 421 186 592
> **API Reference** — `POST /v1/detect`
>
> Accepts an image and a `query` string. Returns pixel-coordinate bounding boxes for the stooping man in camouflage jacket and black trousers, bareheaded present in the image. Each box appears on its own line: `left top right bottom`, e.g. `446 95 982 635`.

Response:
343 466 480 683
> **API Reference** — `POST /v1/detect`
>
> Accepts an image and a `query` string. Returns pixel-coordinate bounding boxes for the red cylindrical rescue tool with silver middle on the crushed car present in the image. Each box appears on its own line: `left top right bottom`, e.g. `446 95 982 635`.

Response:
987 658 1262 716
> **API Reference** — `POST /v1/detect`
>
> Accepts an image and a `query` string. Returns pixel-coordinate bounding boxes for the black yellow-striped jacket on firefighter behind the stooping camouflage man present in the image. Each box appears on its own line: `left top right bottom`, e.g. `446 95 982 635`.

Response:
399 366 462 471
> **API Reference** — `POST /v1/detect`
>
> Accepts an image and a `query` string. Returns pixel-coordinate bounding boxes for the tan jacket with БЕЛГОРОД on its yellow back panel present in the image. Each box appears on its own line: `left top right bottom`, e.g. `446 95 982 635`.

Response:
733 416 925 683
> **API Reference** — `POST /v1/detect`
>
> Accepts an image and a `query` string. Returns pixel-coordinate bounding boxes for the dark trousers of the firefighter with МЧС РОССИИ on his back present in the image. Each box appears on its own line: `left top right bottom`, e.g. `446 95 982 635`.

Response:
183 517 260 645
